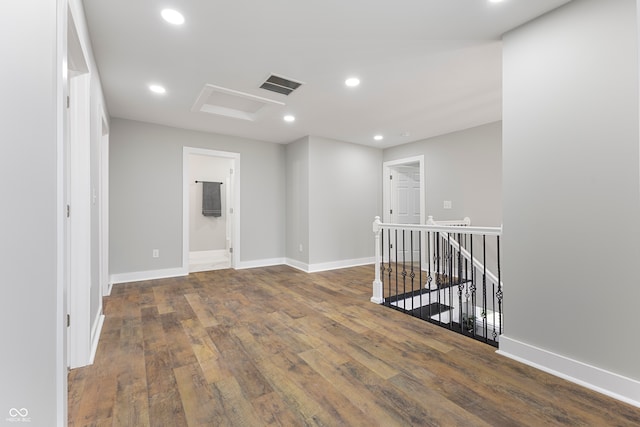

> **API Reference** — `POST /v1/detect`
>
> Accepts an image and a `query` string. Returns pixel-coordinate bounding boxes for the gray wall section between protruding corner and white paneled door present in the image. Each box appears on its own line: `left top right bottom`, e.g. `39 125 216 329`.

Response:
309 136 382 264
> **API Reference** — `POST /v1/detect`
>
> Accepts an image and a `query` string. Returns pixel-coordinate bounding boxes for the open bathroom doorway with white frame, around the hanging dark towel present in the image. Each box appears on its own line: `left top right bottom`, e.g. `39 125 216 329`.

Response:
183 147 240 274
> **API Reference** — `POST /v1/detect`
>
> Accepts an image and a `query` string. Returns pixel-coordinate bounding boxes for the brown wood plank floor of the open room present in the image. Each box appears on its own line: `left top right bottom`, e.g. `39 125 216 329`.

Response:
69 266 640 427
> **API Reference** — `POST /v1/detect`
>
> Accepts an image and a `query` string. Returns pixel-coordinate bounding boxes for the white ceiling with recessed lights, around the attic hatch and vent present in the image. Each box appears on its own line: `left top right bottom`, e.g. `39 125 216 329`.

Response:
83 0 570 147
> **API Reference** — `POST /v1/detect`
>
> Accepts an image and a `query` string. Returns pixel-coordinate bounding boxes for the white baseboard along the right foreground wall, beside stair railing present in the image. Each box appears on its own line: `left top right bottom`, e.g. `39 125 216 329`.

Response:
497 335 640 407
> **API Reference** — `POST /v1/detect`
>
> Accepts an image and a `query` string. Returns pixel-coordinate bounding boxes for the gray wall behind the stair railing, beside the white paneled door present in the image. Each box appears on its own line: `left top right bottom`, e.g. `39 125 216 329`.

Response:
384 122 502 227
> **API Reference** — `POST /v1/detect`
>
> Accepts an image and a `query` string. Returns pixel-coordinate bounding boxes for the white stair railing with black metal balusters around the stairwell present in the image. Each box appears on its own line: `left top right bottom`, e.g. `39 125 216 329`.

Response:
371 217 504 347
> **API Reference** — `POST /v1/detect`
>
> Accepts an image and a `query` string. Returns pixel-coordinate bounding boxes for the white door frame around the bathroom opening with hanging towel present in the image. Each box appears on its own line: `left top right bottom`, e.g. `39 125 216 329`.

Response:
182 147 240 275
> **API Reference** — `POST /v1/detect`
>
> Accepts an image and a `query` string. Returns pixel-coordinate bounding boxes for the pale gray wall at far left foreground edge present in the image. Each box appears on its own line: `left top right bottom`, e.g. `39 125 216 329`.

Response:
0 0 60 426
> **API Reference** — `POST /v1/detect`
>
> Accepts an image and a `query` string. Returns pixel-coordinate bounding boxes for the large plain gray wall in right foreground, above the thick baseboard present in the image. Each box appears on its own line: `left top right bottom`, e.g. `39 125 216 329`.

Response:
503 0 640 380
